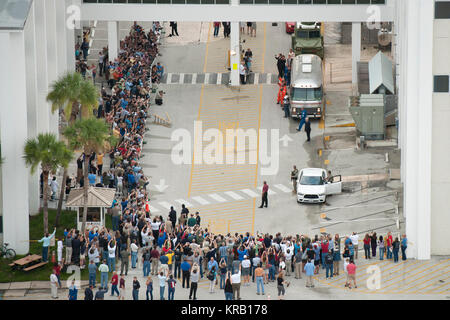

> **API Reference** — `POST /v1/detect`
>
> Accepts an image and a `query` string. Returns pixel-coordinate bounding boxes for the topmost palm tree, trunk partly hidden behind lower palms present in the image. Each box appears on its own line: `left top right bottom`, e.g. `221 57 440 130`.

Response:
47 72 99 226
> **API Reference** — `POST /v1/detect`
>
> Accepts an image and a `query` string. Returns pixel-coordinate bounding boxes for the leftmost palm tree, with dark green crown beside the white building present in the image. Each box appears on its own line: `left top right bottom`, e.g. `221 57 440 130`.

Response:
24 133 73 233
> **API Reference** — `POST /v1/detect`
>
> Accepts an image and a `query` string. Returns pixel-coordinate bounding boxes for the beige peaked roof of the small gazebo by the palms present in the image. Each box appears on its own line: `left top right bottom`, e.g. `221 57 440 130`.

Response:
66 187 116 208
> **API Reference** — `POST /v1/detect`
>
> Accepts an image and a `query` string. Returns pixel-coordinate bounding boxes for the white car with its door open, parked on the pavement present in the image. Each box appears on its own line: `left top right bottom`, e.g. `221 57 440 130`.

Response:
297 168 342 203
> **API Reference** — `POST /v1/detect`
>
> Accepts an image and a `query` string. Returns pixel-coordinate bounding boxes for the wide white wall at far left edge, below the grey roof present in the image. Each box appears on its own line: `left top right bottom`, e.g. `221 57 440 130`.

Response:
0 31 29 254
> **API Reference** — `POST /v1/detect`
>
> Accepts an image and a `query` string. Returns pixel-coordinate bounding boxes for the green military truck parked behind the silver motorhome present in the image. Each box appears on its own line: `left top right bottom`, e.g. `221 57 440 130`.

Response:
292 22 324 59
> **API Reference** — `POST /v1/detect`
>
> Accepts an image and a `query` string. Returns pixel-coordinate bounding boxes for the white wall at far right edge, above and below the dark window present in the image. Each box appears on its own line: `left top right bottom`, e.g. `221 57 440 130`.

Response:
431 19 450 255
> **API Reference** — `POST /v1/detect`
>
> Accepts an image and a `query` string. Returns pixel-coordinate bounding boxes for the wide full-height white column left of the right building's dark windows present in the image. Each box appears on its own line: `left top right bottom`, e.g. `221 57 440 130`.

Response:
402 0 434 259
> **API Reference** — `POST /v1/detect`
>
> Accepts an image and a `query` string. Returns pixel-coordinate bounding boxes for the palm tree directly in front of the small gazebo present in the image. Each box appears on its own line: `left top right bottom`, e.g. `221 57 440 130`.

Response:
64 118 116 233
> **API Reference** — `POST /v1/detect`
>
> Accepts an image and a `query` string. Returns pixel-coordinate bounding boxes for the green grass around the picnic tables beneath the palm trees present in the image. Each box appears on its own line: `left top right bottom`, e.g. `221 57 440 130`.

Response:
0 209 112 283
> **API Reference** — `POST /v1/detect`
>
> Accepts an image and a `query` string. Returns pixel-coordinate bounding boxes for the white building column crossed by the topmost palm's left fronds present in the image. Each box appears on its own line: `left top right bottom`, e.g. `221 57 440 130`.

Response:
44 0 60 135
